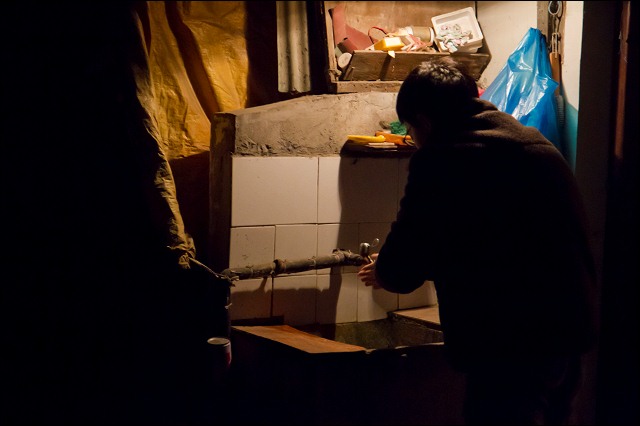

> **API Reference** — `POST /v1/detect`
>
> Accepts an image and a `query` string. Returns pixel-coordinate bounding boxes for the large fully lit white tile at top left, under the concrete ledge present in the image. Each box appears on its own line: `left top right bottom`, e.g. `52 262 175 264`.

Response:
231 157 318 226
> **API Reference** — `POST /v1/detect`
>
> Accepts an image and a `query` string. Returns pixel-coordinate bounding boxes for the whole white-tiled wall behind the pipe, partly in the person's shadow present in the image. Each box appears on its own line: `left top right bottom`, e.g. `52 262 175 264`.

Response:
229 155 436 325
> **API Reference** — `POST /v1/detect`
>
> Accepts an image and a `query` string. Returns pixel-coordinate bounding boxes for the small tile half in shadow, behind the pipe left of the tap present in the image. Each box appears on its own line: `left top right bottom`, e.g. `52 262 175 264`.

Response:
318 223 360 274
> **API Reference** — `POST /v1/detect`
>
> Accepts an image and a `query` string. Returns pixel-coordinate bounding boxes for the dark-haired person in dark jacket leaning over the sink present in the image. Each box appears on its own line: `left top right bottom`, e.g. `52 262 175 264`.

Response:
358 57 598 425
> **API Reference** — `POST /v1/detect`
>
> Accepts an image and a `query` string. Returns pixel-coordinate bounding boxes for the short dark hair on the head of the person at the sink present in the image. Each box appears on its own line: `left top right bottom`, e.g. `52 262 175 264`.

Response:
396 56 478 125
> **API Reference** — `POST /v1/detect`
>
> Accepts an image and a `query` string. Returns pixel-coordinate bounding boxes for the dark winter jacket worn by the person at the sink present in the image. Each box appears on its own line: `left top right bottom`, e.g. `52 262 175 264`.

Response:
376 99 596 369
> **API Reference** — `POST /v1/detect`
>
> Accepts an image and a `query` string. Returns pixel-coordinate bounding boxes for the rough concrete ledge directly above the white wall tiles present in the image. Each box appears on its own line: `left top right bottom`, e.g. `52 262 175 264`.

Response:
211 92 398 156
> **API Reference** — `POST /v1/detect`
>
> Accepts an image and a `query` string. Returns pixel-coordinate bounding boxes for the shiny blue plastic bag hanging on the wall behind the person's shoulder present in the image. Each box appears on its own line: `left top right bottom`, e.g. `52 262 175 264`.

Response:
480 28 561 150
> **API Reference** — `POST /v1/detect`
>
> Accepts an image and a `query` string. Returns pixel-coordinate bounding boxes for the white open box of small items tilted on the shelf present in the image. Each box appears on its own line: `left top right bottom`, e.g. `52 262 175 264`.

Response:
431 7 483 53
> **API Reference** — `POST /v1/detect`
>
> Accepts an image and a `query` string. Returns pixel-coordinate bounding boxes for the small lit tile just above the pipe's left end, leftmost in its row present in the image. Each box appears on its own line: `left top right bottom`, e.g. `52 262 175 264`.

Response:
229 226 276 268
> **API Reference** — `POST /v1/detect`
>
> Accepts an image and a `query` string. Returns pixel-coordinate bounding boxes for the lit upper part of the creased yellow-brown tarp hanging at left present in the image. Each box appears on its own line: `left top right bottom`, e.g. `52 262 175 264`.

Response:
137 1 248 159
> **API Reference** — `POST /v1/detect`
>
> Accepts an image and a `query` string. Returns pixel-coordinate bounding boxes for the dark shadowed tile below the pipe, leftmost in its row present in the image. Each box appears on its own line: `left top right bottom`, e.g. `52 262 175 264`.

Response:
229 278 273 321
